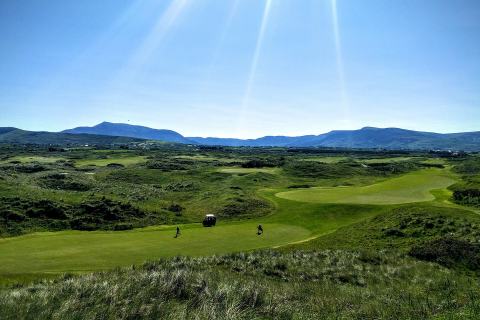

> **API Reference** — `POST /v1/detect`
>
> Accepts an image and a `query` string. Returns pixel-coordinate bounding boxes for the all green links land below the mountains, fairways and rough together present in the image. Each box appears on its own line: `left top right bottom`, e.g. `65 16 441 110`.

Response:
0 144 480 319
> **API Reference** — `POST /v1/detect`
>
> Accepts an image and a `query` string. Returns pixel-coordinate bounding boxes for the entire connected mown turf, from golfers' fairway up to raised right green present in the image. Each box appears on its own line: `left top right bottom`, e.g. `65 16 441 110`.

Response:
0 165 455 278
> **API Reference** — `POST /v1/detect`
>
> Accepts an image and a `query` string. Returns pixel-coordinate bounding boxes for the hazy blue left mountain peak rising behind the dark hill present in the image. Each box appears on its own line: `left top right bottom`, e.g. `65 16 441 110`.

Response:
62 122 193 144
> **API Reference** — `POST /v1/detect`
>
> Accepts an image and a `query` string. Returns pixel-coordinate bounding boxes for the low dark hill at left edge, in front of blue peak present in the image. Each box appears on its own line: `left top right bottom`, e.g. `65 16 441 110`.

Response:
0 127 145 145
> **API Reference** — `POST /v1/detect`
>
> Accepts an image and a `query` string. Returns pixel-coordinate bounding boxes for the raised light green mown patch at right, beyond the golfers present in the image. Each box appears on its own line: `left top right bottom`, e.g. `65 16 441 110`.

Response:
276 168 455 205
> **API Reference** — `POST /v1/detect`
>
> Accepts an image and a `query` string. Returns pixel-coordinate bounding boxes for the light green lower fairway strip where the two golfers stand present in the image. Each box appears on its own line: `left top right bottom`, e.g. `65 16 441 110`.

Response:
0 222 311 277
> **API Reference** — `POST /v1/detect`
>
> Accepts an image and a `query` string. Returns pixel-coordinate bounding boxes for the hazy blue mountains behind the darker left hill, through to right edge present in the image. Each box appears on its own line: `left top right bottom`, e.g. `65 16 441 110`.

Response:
63 122 480 151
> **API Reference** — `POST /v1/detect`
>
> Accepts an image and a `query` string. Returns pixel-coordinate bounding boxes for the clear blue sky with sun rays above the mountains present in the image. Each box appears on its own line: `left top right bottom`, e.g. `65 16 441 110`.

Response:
0 0 480 138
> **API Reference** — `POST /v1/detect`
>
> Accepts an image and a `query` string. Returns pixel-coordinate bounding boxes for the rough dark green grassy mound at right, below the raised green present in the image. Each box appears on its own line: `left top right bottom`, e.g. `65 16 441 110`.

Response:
302 204 480 252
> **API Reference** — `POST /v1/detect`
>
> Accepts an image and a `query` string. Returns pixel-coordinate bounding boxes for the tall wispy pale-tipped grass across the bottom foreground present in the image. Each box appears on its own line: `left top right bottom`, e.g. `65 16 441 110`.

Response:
0 250 480 319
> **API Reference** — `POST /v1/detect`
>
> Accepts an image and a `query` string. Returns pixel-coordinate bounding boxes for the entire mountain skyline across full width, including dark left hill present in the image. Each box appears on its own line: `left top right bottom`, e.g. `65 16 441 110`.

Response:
0 122 480 151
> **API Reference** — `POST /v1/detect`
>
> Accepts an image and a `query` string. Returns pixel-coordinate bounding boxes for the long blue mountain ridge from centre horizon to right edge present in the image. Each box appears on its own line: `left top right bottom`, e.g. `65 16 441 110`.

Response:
188 127 480 151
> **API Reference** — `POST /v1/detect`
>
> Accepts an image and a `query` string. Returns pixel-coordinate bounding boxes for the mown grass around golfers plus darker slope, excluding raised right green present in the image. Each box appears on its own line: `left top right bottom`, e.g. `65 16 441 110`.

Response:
0 196 383 285
